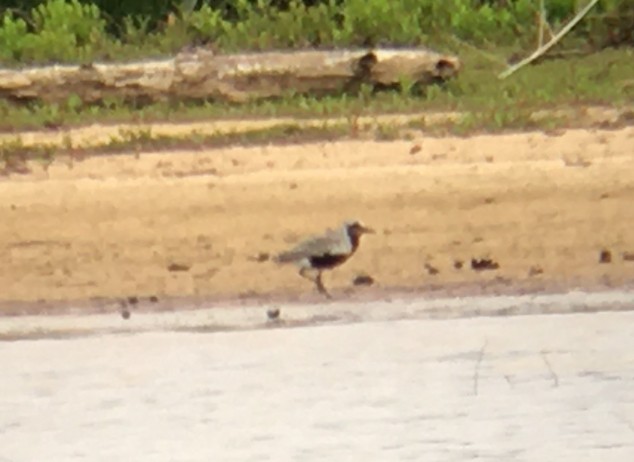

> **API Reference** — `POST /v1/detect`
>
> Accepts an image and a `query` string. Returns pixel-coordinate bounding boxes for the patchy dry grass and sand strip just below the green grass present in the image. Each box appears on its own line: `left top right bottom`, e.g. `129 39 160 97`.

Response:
0 98 634 176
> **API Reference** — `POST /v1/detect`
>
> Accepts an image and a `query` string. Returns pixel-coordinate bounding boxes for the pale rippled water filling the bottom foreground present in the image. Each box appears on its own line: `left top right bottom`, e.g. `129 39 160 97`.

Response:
0 294 634 462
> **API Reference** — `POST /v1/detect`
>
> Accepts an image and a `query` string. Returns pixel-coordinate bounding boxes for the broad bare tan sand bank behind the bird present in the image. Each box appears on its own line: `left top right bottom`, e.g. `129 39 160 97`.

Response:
0 122 634 314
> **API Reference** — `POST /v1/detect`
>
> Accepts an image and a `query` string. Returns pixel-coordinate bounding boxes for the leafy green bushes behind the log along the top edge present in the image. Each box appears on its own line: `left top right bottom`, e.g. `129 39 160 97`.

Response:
0 0 634 65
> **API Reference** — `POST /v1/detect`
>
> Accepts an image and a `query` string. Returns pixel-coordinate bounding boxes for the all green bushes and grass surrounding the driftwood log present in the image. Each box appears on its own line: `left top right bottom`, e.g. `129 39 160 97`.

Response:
0 0 634 136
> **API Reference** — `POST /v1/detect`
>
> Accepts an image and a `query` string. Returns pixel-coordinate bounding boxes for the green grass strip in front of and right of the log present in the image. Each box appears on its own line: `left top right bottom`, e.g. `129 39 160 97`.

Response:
0 48 634 132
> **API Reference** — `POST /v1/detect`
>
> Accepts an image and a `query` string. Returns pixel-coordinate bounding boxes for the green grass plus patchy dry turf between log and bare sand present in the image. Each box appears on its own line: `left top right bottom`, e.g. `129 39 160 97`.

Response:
0 39 634 174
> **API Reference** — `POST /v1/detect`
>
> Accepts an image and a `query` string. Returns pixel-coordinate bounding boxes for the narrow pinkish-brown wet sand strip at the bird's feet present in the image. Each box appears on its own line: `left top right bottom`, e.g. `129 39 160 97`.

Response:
0 278 634 319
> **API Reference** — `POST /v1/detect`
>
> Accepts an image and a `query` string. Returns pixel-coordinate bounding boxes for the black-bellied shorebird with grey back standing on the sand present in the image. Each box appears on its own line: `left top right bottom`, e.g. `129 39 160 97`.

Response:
273 220 374 298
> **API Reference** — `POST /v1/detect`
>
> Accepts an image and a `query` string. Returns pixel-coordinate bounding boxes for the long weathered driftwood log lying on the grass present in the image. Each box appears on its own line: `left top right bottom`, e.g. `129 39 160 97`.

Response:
0 48 460 103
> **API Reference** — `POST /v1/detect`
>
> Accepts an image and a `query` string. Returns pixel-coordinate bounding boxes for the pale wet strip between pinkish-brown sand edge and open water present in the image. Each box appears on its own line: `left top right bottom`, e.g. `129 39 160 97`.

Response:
0 287 634 343
